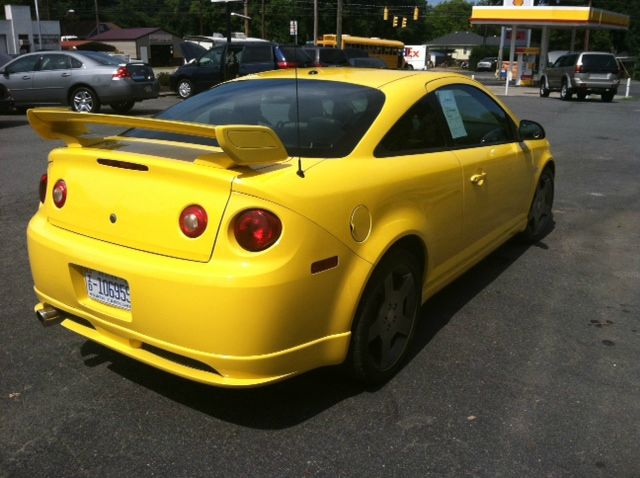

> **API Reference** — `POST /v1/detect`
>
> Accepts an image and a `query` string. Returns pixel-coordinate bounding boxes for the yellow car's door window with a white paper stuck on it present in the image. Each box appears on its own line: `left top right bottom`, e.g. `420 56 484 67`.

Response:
436 85 516 147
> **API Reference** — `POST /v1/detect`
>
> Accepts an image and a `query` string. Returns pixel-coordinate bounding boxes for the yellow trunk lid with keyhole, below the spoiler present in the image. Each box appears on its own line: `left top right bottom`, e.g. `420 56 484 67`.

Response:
44 147 237 262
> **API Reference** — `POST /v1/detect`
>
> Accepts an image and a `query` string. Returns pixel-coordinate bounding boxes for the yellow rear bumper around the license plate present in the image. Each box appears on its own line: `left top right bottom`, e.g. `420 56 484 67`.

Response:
27 204 370 387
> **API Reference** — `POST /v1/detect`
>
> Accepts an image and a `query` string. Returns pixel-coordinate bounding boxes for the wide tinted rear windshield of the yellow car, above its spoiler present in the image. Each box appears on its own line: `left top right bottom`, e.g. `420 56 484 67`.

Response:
124 79 384 158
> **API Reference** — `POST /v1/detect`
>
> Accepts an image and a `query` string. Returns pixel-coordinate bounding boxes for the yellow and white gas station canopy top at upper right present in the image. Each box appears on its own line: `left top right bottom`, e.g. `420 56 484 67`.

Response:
470 6 629 30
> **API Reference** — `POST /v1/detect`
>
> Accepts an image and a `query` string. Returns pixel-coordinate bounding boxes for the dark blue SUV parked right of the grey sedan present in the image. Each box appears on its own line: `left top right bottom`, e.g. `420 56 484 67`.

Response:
170 41 311 98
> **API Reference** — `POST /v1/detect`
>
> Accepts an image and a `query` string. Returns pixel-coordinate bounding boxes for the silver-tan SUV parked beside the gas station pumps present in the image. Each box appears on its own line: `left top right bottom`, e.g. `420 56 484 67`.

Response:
540 51 620 102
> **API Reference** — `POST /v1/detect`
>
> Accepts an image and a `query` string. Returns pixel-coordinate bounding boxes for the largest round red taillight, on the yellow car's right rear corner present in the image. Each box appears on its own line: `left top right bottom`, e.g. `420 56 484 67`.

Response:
233 209 282 252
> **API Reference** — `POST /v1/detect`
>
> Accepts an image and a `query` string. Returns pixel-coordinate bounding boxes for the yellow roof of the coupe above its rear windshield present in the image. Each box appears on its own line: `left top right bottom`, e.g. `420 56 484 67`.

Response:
234 67 466 88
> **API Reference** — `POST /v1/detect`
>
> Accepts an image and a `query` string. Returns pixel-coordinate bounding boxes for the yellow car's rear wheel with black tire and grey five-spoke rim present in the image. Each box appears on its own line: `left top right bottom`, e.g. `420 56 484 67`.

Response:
347 249 422 385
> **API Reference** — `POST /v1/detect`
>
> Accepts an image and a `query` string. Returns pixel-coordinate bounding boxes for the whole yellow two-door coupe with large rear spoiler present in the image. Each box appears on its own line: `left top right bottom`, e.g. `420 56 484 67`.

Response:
27 68 555 387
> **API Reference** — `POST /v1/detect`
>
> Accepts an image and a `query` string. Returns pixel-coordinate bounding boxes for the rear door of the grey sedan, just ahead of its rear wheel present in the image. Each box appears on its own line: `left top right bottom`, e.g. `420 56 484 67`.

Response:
33 53 77 105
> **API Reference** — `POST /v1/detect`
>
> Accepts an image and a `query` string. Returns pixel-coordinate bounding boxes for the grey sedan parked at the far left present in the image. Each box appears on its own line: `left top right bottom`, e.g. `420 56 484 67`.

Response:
0 51 160 113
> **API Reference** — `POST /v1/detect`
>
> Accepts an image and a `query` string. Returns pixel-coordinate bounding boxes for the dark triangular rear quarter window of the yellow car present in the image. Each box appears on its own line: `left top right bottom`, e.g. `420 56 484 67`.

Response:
374 95 448 157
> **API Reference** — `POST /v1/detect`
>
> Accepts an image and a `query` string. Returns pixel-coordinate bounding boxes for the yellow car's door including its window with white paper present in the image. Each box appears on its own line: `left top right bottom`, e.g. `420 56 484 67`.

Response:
435 84 533 255
